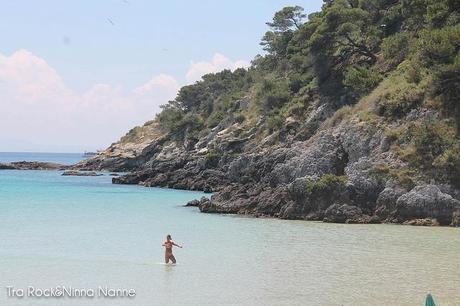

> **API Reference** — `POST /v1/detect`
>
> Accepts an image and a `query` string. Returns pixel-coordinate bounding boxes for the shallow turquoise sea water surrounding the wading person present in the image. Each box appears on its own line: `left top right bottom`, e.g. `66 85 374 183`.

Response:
0 154 460 305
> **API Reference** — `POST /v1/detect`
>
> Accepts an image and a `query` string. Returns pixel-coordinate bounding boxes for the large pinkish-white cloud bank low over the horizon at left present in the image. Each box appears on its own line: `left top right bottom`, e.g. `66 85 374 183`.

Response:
0 50 179 151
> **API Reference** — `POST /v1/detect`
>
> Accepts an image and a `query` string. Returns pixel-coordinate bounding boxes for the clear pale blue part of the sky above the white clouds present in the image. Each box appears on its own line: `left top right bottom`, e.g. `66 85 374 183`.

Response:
0 0 322 151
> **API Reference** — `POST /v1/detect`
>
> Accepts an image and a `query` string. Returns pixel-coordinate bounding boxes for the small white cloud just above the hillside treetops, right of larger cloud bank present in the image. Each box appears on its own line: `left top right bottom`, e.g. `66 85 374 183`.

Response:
185 53 250 83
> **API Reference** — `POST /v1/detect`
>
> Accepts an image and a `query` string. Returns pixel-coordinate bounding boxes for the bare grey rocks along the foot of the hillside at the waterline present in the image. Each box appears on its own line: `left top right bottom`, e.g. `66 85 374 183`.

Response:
76 108 460 226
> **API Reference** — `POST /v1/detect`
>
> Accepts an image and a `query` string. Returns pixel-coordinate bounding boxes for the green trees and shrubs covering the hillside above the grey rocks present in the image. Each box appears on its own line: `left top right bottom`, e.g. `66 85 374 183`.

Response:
148 0 460 186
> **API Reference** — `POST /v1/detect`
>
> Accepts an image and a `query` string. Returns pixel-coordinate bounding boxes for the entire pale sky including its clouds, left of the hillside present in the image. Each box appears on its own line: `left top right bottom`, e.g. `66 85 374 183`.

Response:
0 0 322 152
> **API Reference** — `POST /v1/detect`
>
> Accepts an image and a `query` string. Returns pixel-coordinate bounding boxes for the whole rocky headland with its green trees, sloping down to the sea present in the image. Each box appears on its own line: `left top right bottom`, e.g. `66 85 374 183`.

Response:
77 1 460 226
